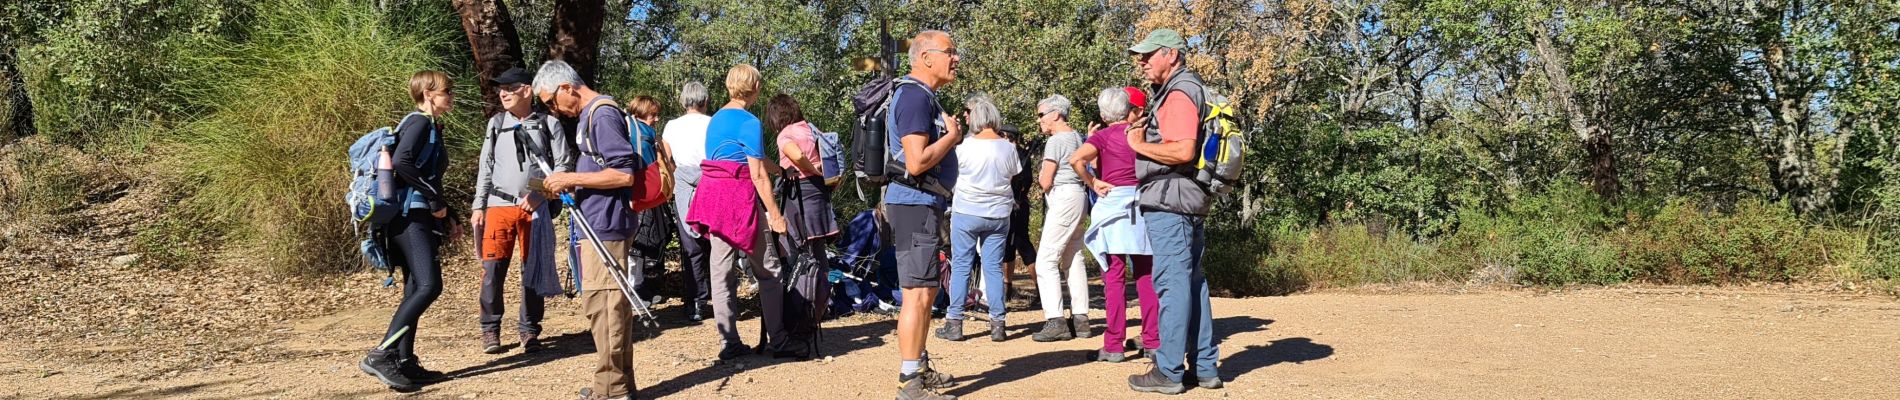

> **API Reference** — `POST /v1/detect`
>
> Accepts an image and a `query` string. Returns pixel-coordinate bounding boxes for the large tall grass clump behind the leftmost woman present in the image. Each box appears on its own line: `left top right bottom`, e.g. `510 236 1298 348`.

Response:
171 0 461 275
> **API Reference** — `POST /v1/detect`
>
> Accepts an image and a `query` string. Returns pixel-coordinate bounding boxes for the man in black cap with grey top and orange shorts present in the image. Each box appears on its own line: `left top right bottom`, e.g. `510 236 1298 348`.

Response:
469 68 574 355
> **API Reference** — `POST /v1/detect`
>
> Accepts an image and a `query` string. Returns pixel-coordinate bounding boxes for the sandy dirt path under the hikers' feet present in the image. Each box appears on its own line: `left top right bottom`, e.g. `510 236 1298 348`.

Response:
0 288 1900 398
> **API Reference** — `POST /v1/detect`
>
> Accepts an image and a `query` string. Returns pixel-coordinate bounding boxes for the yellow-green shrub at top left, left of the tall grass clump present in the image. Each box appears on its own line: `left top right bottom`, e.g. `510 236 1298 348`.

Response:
17 0 249 146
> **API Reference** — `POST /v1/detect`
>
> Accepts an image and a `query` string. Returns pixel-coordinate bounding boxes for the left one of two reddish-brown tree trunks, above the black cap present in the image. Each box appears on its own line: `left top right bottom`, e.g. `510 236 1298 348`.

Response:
454 0 534 116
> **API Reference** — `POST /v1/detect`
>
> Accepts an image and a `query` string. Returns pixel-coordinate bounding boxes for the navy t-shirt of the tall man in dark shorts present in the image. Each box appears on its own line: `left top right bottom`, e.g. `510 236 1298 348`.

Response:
884 76 956 209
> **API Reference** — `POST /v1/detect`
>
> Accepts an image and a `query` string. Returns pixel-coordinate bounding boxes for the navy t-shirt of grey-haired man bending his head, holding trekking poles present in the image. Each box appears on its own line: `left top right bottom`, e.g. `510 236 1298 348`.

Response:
574 97 640 241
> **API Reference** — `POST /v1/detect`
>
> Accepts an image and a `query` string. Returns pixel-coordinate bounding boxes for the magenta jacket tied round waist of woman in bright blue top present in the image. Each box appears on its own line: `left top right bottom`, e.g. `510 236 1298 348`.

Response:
686 159 758 252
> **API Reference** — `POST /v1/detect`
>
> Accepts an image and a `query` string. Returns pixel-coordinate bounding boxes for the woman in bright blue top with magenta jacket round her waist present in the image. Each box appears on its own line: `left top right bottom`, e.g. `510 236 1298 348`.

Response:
686 64 785 360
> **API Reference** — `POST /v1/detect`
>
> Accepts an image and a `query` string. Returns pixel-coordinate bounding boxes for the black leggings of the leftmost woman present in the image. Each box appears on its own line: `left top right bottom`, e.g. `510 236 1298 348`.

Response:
378 209 443 360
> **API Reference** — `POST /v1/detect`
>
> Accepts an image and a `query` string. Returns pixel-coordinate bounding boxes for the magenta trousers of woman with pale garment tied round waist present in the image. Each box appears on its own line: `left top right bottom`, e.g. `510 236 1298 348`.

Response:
1102 254 1161 353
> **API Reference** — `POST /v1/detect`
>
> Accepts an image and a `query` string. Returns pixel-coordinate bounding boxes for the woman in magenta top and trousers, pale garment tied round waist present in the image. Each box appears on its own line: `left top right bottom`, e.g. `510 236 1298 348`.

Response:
1068 87 1161 362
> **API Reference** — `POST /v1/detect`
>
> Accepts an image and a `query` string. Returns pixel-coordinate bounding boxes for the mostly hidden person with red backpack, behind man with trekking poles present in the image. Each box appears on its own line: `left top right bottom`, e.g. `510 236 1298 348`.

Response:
625 95 675 309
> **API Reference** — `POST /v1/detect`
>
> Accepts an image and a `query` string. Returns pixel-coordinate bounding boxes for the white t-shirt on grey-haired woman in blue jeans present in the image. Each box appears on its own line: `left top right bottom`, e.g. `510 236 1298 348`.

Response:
950 136 1022 218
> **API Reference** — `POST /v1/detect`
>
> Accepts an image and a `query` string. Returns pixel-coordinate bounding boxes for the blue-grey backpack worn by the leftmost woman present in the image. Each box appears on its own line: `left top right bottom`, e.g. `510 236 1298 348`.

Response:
344 112 439 269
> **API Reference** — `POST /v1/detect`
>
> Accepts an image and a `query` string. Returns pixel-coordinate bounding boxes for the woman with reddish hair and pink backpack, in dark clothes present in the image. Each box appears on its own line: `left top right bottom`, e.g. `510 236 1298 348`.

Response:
766 95 838 358
